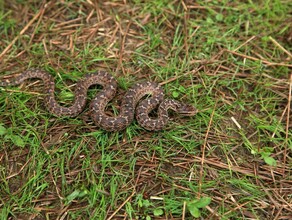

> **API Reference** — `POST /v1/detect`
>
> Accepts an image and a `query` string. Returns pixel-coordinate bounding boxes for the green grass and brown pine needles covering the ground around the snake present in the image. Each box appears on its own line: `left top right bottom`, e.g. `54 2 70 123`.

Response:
0 0 292 220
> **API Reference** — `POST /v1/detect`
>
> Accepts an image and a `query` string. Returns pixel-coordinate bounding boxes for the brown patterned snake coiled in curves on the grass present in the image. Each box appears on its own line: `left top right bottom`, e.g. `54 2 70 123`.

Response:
0 69 197 132
